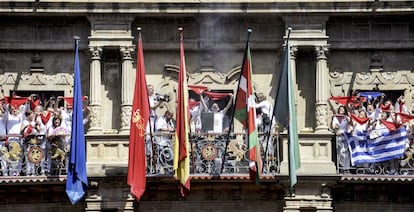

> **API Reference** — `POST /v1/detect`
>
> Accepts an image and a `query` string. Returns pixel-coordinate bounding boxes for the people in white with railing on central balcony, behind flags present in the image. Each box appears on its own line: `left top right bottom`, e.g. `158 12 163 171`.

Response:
146 85 277 174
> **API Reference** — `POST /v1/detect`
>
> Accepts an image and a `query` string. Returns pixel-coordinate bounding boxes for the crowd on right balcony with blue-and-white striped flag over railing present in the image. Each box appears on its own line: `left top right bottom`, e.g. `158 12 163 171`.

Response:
330 91 414 174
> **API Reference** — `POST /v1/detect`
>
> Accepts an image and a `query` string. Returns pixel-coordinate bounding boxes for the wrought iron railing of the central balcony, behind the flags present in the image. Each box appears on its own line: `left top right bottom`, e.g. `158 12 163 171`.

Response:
146 133 280 175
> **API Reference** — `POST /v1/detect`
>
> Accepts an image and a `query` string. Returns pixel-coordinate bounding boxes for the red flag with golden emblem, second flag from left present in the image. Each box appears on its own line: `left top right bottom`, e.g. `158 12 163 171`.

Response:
128 28 150 200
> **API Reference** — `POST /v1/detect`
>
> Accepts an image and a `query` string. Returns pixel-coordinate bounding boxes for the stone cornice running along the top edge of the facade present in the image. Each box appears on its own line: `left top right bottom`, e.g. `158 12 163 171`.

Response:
0 0 414 15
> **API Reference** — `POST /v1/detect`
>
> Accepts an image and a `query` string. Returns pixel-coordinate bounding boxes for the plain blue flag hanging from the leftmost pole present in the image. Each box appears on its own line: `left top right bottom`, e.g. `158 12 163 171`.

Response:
66 37 88 204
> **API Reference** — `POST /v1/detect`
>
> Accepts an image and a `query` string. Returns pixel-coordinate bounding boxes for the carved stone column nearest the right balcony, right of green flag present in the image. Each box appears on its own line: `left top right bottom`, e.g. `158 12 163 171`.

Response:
315 46 329 132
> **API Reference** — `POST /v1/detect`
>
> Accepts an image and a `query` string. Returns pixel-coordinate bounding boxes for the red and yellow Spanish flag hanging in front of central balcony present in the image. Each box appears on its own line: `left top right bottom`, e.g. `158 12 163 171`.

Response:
174 28 190 196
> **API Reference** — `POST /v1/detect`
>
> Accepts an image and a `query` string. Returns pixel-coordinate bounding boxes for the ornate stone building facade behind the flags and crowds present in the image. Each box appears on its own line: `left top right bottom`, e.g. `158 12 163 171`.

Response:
0 0 414 212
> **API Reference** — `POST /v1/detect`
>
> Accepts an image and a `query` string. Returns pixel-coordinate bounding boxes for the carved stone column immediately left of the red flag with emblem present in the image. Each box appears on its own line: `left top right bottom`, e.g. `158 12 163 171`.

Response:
119 46 135 134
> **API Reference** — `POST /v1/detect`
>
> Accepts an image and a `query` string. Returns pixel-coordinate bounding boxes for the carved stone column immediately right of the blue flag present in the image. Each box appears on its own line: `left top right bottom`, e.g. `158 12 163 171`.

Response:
88 46 102 134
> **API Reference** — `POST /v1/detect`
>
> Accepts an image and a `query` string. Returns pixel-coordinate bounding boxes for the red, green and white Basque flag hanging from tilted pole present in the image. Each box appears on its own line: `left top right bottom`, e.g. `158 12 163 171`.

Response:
234 29 262 183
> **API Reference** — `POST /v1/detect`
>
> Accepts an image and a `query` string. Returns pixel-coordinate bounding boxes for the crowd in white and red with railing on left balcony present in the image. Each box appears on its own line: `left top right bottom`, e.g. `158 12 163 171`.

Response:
0 93 89 176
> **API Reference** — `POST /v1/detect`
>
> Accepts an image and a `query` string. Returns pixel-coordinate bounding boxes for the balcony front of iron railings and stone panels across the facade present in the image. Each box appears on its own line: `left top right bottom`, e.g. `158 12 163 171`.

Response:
0 133 414 179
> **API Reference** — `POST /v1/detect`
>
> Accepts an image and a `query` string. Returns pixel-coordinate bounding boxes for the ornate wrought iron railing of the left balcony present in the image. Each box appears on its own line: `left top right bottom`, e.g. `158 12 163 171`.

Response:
0 134 70 176
